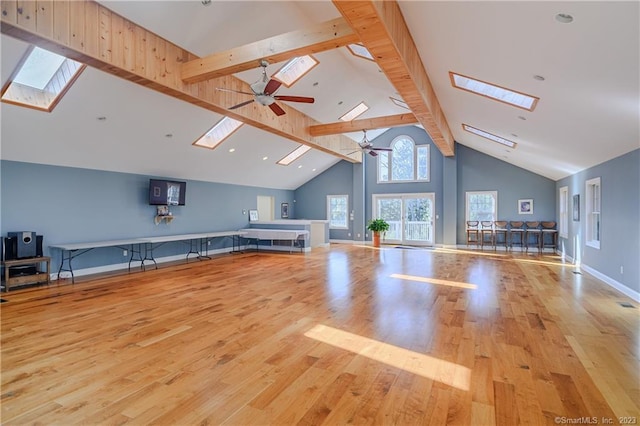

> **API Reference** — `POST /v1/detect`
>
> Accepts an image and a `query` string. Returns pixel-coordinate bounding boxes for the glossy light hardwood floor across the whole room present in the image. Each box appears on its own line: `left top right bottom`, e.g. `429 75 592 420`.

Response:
0 244 640 425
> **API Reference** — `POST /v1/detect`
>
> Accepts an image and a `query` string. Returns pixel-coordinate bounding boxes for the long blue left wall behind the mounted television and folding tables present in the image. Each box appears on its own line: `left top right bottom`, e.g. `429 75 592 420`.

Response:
0 160 295 270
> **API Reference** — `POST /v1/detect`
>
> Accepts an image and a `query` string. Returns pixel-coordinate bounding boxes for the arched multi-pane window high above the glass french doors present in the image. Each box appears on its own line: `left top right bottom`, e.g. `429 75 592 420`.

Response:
378 135 430 183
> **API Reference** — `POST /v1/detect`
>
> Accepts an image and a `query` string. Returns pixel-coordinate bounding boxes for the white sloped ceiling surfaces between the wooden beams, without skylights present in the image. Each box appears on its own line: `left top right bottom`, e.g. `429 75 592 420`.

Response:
0 0 640 189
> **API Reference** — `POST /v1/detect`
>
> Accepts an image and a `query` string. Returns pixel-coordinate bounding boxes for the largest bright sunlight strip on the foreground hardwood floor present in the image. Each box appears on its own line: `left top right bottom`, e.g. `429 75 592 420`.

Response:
304 324 471 391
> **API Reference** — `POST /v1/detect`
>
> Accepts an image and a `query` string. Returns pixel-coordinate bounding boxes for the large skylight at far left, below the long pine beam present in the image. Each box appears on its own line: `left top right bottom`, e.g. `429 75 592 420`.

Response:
2 47 85 111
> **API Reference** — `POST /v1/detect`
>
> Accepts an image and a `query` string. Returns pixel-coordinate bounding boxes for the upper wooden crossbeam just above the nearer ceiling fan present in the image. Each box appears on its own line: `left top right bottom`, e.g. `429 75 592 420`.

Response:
182 18 360 83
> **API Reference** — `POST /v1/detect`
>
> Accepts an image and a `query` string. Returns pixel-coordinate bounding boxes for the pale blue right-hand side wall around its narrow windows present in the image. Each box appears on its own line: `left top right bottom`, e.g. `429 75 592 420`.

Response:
555 149 640 293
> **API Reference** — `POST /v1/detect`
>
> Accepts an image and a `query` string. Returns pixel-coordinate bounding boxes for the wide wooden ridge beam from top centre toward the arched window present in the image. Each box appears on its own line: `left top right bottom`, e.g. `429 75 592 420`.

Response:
333 0 454 156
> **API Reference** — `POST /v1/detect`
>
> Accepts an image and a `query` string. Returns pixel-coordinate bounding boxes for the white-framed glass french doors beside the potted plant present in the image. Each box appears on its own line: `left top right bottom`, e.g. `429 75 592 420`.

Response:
373 192 435 246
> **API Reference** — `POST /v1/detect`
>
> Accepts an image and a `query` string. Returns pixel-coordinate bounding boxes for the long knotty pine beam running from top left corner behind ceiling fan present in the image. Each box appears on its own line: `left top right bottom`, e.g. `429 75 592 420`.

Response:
0 0 362 163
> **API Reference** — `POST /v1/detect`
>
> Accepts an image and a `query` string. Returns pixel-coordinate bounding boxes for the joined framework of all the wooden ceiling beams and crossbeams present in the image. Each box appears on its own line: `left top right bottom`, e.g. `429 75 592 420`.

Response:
1 0 453 162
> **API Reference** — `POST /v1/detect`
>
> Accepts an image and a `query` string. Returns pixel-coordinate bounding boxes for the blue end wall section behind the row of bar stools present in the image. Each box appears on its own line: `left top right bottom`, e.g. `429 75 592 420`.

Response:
456 145 557 244
